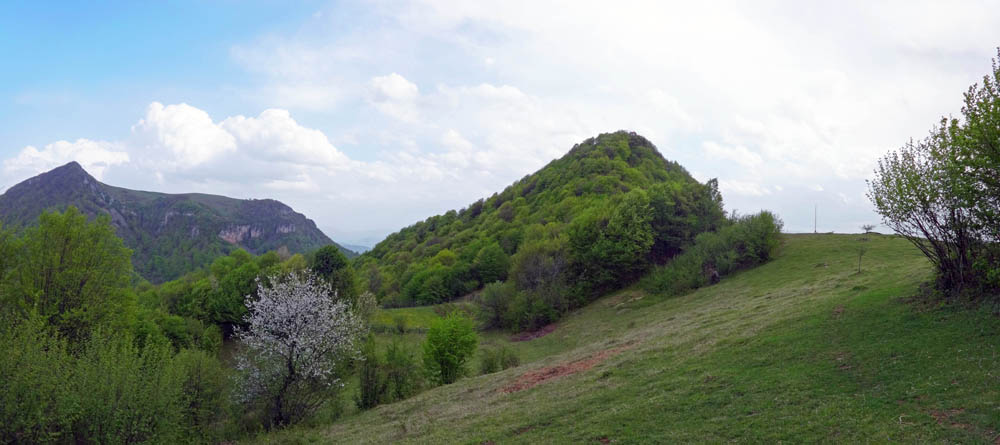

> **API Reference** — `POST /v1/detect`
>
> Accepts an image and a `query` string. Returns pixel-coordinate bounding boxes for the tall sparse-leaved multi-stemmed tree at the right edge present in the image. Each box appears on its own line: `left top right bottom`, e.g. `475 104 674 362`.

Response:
859 50 1000 298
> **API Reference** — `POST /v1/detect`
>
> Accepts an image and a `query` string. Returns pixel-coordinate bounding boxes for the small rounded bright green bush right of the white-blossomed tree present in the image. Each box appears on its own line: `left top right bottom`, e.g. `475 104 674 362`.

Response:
423 311 479 385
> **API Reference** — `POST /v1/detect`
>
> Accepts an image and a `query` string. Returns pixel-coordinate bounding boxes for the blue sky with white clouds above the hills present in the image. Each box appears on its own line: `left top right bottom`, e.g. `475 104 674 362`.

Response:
0 0 1000 246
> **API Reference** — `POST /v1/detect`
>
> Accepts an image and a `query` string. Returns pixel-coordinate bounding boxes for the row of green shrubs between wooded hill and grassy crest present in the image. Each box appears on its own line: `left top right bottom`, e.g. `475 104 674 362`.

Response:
642 211 782 295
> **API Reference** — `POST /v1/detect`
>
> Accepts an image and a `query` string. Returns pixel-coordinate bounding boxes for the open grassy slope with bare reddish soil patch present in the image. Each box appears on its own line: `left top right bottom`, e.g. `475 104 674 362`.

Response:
257 235 1000 443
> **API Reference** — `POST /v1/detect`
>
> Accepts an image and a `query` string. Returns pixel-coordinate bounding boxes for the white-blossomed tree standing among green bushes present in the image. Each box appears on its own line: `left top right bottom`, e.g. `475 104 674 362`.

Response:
236 271 364 427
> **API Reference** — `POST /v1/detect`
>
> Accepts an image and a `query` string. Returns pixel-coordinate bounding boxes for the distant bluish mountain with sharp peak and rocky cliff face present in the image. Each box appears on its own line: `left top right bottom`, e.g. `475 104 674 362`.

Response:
0 162 354 283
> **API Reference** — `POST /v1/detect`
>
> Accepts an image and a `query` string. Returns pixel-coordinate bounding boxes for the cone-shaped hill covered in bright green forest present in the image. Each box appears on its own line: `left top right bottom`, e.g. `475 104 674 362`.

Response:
355 131 725 306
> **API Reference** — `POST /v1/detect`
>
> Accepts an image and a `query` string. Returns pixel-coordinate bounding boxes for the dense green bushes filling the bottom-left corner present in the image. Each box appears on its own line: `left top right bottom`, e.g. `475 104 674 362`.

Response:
0 314 229 443
